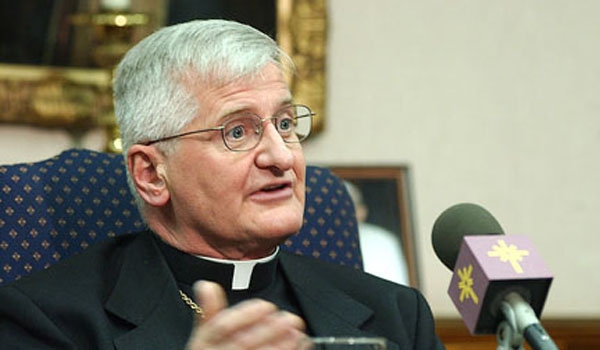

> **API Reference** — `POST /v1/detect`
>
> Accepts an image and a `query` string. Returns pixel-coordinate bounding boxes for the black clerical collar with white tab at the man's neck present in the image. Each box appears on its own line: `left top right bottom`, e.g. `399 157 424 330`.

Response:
156 237 279 292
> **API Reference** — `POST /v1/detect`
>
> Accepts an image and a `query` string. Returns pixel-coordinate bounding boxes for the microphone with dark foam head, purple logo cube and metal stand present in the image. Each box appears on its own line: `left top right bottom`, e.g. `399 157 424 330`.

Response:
431 203 558 349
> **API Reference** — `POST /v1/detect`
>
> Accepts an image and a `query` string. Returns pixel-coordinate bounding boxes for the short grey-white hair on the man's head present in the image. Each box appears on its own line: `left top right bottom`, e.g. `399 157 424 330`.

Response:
113 20 293 156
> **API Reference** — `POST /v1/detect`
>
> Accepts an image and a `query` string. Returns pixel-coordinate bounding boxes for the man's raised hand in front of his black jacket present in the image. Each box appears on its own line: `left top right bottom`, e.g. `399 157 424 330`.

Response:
186 281 306 350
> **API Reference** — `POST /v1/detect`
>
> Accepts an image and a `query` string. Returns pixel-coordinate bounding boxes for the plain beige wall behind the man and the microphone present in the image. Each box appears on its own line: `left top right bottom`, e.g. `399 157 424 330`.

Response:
0 0 600 317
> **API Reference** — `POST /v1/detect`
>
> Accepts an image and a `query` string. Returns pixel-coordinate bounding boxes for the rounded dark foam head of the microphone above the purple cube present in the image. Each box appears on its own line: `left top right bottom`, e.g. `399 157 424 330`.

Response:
431 203 504 270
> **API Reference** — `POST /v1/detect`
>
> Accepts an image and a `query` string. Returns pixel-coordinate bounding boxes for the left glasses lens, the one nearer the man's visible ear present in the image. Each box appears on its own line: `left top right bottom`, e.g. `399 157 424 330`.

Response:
222 114 262 151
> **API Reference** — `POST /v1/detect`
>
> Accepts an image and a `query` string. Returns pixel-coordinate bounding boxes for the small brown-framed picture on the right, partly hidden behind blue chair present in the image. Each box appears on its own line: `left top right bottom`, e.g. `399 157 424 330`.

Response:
330 165 419 288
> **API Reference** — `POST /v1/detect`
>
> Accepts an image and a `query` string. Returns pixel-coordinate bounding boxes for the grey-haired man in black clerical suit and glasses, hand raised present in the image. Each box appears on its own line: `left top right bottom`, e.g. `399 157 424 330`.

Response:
0 20 443 349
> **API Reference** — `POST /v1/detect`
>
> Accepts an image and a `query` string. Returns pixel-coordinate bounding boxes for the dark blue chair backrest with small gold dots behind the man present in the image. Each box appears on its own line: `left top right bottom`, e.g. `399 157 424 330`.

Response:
0 149 362 284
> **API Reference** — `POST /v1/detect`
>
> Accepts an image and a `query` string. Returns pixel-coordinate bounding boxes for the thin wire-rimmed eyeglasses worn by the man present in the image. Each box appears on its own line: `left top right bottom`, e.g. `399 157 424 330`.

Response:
142 105 315 152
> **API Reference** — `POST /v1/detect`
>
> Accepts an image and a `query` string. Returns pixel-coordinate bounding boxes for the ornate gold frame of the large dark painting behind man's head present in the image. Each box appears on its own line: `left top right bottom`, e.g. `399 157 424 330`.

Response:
0 0 327 151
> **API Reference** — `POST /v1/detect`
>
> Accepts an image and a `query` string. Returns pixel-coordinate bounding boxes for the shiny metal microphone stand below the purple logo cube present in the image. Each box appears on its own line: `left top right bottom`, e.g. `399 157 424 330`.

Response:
496 292 558 350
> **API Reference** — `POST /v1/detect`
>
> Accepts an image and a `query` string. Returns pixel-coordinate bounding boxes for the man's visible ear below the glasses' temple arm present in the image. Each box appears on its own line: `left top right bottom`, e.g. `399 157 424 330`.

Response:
127 145 170 207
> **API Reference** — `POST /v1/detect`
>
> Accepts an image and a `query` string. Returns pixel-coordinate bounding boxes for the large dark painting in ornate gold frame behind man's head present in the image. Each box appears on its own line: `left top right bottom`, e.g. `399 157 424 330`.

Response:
0 0 327 152
